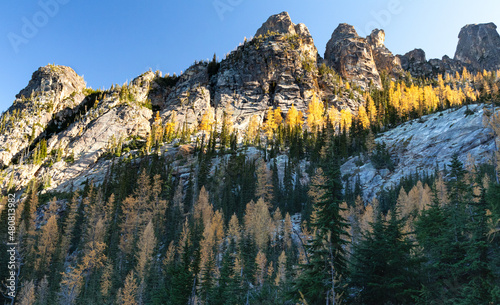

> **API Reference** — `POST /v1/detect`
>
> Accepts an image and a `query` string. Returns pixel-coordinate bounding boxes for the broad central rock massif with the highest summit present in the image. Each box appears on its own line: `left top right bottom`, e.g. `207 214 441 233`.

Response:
158 12 334 131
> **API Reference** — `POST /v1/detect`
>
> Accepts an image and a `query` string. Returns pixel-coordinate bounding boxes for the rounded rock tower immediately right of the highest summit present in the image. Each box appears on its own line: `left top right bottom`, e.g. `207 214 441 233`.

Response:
325 23 382 88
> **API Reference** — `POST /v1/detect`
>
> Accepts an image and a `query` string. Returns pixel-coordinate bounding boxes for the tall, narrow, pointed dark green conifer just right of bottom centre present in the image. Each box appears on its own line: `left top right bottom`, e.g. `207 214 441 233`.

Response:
293 149 348 305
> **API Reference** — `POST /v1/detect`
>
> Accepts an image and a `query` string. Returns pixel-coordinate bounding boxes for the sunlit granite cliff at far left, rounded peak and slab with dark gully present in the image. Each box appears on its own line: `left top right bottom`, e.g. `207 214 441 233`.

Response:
0 65 153 191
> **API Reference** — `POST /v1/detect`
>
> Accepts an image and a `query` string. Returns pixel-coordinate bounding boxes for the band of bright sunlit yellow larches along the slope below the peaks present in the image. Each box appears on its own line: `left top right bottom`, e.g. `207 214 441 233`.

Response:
143 69 500 150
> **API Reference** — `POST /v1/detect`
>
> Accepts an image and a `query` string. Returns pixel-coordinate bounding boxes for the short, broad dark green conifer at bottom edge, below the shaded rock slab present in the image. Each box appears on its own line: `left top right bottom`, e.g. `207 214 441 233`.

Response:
350 211 420 304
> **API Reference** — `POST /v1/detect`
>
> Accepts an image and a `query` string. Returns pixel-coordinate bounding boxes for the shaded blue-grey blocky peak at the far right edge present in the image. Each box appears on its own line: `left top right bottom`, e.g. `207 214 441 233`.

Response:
455 23 500 70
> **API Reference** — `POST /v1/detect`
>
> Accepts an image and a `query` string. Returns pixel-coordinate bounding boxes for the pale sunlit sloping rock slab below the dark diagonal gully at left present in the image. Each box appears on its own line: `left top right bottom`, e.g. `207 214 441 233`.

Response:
2 72 155 192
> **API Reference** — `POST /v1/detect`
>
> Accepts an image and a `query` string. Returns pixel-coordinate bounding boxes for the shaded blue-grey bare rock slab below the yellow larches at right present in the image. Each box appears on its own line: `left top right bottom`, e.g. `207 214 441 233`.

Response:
341 105 495 201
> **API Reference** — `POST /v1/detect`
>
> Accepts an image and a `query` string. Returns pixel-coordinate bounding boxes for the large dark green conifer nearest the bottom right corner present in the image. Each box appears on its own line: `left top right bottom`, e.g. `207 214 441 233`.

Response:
416 155 493 305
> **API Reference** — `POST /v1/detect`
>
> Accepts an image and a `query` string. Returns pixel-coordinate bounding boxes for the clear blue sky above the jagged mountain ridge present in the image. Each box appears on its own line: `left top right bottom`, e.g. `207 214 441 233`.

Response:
0 0 500 111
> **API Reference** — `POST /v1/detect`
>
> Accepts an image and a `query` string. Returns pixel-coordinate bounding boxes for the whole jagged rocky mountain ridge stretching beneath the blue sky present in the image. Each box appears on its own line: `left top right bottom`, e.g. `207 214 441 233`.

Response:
0 12 498 195
